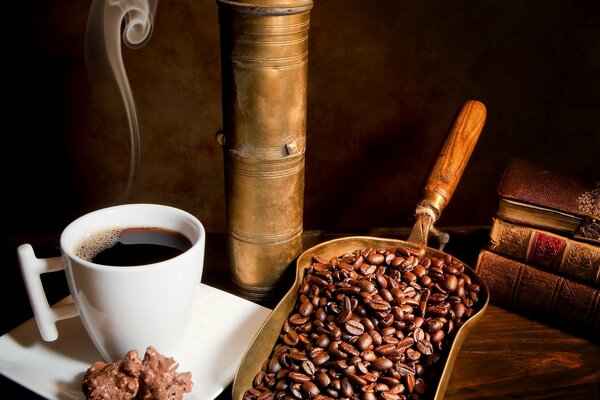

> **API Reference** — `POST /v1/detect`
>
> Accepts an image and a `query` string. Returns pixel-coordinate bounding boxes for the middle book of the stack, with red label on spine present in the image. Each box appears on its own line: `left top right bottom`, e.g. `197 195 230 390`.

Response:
488 218 600 288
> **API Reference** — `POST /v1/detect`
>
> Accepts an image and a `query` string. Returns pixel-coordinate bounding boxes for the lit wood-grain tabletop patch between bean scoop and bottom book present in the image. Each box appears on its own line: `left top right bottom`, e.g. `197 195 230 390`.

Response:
446 305 600 400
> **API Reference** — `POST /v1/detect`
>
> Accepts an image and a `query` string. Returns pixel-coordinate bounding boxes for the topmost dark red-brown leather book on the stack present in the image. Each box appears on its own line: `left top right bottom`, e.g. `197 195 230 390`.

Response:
497 159 600 244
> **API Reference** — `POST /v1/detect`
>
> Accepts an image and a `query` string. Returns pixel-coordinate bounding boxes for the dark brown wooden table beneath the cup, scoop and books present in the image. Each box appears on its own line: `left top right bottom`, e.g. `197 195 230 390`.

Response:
0 227 600 400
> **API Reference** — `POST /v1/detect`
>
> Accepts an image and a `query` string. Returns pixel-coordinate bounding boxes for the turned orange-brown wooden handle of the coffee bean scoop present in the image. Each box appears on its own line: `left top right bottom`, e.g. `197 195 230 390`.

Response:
417 100 487 220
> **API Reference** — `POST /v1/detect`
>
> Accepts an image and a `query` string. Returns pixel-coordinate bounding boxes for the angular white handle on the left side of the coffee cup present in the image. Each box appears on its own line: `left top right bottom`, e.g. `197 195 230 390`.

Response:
17 244 79 342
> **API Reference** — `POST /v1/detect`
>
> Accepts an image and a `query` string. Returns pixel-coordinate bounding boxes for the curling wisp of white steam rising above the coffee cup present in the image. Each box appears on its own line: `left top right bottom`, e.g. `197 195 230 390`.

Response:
85 0 158 199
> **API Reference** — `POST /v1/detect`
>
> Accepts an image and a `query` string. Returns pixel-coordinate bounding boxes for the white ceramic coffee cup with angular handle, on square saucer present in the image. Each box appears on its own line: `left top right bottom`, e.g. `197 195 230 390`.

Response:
18 204 206 361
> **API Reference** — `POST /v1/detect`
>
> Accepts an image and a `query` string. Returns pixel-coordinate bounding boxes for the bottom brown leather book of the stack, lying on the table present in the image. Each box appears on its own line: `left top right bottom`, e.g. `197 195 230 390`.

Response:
475 249 600 337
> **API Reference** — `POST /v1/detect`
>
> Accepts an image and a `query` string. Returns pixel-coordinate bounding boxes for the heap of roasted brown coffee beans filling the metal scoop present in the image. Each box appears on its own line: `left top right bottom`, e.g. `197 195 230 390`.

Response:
244 247 480 400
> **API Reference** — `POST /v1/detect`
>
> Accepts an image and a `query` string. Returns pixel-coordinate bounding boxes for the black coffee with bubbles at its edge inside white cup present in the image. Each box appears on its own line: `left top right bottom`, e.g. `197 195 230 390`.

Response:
76 227 192 267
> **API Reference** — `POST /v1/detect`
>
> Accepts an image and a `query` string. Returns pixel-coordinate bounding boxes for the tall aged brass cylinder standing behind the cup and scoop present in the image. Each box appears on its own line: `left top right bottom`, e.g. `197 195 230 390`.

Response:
217 0 313 300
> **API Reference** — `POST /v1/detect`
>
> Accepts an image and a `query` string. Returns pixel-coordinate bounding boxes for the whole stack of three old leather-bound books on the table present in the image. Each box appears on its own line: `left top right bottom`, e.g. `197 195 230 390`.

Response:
475 159 600 337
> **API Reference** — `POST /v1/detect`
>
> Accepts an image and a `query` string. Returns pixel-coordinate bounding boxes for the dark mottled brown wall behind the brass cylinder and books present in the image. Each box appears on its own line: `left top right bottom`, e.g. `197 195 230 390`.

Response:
0 0 600 235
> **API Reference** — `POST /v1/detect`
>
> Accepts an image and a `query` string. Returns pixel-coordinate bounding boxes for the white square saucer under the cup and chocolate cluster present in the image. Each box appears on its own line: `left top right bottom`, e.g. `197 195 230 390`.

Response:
0 283 271 400
